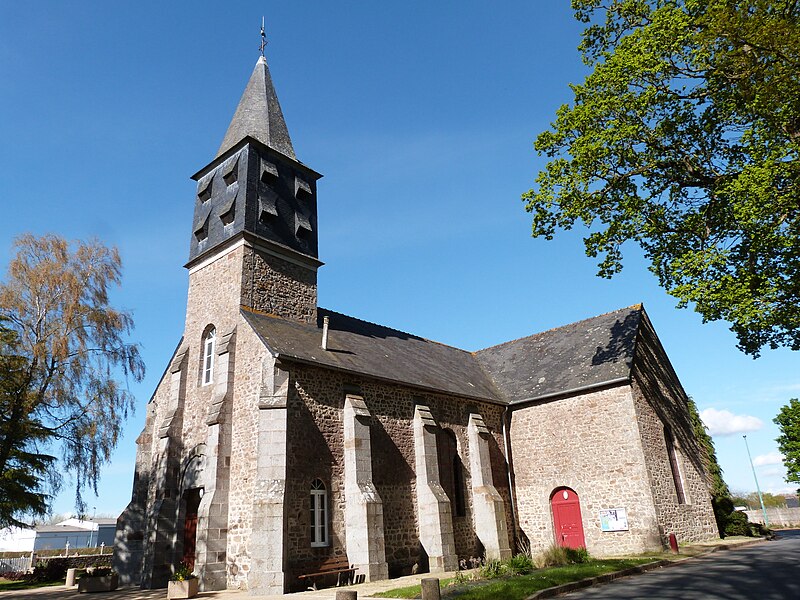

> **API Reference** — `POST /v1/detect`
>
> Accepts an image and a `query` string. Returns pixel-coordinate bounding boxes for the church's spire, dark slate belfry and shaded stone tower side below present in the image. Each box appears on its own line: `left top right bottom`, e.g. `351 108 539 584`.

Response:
186 56 322 323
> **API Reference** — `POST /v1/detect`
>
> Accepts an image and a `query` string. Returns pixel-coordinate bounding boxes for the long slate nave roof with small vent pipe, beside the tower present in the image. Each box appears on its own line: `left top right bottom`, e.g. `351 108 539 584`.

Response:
242 308 501 402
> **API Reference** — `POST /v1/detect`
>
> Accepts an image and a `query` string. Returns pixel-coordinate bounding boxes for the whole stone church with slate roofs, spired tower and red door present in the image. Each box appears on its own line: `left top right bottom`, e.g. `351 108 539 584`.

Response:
115 49 716 594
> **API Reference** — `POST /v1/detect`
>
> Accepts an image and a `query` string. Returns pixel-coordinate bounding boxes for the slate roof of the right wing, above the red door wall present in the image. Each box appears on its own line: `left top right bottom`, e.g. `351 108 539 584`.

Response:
475 304 644 403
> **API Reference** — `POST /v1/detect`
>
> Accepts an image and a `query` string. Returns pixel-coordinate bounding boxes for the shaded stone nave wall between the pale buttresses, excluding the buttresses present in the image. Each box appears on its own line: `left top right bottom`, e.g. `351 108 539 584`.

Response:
286 366 511 582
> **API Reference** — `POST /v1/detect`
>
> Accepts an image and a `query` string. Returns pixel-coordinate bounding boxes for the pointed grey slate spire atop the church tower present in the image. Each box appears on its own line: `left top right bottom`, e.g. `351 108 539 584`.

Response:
217 56 297 160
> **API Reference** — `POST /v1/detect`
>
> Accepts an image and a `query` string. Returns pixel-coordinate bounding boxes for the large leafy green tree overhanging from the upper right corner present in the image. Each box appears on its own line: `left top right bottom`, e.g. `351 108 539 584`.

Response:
523 0 800 356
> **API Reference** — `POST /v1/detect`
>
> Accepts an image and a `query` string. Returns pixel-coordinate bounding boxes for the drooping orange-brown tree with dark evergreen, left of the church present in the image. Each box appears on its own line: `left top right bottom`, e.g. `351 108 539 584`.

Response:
0 235 144 526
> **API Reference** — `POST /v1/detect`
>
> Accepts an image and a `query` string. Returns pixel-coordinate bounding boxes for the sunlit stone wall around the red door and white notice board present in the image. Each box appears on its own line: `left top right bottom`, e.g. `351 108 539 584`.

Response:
510 385 661 556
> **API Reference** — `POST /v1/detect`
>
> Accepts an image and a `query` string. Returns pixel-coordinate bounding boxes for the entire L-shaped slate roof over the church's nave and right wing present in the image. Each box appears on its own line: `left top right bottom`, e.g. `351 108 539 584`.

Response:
242 305 644 404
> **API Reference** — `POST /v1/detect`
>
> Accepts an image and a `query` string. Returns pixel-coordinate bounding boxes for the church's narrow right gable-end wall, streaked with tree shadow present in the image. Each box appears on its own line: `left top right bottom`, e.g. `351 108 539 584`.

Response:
632 322 719 543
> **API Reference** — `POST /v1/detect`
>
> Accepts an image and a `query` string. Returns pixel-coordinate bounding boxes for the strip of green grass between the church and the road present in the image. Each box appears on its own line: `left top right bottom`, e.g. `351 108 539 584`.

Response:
375 558 653 600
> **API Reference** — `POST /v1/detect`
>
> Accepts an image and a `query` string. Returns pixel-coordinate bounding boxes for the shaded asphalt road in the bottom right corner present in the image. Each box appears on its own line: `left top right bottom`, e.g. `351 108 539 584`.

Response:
561 530 800 600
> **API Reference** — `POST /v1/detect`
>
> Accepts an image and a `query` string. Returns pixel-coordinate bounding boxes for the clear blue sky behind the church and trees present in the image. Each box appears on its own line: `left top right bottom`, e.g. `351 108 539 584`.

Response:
0 0 800 514
